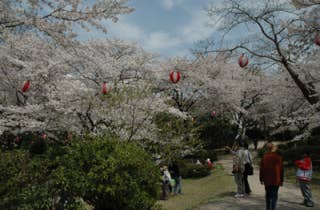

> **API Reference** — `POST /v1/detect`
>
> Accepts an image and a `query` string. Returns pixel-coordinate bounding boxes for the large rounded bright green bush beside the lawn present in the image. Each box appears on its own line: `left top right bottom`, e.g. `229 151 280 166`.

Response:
59 135 159 210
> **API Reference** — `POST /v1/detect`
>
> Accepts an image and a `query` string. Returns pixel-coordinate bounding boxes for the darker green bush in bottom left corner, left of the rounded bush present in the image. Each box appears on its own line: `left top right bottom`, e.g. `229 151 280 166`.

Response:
0 150 66 209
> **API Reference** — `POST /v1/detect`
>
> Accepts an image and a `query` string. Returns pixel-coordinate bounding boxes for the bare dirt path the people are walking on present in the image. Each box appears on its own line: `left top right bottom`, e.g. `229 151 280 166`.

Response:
196 156 320 210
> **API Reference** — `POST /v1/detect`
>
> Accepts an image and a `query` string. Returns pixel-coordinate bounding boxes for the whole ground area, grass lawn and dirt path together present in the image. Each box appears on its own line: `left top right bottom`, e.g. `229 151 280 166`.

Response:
158 155 320 210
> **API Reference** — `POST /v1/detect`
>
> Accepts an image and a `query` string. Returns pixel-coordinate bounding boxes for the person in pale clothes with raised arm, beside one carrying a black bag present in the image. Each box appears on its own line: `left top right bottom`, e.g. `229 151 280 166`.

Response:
226 142 245 198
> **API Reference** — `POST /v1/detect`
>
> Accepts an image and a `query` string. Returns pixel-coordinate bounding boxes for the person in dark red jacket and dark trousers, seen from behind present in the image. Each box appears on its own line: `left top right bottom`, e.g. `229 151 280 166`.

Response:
260 143 283 210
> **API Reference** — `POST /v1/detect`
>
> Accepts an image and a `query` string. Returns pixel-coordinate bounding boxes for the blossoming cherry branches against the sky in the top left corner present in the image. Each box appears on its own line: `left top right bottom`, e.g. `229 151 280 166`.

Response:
0 0 133 46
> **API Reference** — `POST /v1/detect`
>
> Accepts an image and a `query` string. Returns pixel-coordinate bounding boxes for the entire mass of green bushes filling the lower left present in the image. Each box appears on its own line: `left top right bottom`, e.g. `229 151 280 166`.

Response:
0 137 159 210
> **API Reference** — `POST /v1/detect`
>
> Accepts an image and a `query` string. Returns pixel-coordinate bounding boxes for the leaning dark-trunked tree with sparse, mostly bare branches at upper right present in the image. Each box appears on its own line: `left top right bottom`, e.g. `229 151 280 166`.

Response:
207 0 319 108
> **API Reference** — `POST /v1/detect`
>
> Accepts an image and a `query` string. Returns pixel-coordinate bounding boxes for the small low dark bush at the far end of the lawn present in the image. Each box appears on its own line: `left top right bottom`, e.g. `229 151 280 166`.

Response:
179 160 210 178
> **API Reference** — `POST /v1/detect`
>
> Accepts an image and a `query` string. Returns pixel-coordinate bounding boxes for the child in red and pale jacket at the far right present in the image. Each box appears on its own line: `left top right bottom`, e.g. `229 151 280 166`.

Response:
294 153 313 207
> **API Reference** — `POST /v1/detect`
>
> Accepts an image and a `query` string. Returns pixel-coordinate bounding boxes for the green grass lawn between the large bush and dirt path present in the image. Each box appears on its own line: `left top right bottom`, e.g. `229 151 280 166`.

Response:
157 169 236 210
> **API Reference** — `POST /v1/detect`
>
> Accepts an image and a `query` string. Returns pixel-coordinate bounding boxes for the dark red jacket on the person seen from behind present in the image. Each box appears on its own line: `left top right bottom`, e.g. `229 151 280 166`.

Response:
260 153 283 186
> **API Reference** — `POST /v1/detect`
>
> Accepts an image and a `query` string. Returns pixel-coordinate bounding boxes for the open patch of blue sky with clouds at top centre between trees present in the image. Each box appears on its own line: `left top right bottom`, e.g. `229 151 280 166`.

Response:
83 0 219 57
